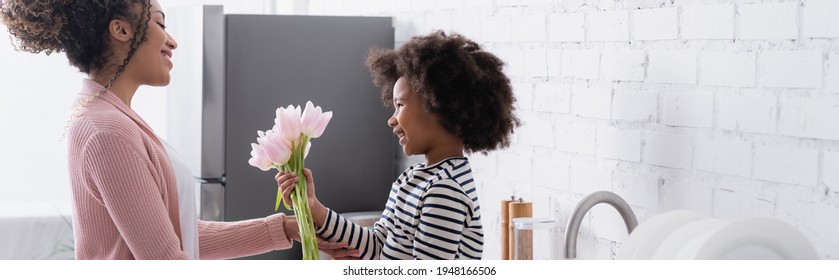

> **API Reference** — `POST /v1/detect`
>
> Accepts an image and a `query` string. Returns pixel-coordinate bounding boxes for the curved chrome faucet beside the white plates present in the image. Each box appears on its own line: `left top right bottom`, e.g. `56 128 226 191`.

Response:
565 191 638 259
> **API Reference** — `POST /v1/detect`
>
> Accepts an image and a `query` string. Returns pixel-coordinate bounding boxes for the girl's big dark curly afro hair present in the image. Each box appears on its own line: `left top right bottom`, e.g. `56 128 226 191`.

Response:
367 31 520 154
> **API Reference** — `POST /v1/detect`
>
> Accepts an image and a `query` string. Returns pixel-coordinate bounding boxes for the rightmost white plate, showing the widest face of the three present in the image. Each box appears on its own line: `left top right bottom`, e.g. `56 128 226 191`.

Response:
695 217 819 260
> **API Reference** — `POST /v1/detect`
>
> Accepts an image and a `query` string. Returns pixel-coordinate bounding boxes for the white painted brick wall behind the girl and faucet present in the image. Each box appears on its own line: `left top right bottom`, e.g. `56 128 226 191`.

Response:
308 0 839 259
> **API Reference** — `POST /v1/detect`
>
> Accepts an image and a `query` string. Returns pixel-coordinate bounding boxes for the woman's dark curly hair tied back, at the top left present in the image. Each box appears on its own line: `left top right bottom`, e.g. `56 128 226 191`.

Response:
0 0 151 75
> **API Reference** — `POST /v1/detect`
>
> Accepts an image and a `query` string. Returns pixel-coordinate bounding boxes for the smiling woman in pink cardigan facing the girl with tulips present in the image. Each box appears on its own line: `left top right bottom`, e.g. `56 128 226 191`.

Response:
1 0 355 259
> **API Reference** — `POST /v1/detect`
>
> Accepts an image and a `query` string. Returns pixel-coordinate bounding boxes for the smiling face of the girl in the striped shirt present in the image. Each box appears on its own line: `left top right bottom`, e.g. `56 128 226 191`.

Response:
387 77 447 158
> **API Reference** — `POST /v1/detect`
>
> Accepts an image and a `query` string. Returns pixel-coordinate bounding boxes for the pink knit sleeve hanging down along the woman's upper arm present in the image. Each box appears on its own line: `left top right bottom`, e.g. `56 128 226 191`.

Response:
83 131 186 259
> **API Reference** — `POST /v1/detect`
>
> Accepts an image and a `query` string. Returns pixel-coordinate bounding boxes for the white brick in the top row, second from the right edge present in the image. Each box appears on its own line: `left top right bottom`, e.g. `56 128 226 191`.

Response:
737 3 798 40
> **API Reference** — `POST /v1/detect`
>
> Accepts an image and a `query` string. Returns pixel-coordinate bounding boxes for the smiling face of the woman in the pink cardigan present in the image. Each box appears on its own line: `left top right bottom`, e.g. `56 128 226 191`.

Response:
126 0 178 86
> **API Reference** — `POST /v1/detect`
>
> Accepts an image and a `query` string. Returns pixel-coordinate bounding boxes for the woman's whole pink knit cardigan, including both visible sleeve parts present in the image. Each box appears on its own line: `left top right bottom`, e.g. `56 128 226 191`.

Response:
67 79 291 259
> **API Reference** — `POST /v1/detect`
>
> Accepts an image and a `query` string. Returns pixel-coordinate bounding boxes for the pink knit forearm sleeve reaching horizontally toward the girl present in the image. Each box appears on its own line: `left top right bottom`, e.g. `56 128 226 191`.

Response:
198 213 292 259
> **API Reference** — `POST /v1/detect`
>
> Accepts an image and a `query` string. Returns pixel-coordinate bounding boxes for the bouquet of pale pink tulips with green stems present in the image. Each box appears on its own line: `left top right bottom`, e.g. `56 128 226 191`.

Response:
248 101 332 260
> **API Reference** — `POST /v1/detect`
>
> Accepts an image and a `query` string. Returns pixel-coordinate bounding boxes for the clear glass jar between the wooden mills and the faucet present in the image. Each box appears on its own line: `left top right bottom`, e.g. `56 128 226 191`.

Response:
512 217 561 260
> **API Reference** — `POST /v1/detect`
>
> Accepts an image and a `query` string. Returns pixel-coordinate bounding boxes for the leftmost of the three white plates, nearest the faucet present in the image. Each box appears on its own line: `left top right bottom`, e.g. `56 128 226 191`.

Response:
615 210 708 260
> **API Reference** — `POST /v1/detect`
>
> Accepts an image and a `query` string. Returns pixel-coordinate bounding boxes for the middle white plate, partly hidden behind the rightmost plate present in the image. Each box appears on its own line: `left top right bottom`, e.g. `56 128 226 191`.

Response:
652 218 730 260
